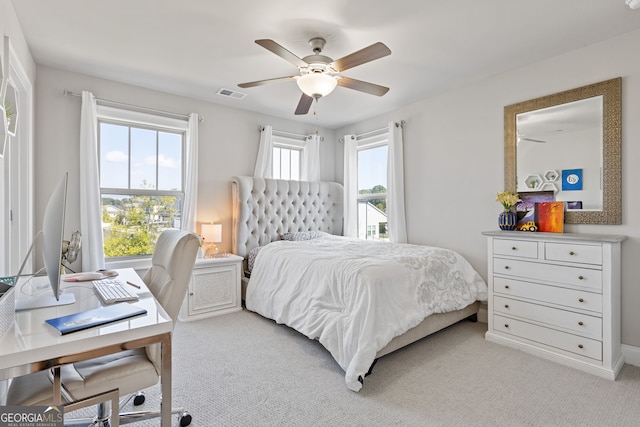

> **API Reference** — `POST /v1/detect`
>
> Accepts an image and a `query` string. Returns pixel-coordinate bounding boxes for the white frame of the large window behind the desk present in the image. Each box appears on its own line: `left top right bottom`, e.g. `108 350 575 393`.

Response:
96 104 189 262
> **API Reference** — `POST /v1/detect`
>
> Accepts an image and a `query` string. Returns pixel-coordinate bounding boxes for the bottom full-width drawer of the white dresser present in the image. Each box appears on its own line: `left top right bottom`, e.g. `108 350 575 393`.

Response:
493 315 602 360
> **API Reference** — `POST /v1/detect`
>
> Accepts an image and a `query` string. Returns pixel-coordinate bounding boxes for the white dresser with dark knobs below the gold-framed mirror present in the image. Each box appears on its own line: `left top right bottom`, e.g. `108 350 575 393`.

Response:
482 231 625 379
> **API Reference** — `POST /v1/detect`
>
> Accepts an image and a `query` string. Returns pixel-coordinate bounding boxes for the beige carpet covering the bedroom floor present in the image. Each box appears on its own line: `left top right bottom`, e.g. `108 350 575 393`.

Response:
77 311 640 427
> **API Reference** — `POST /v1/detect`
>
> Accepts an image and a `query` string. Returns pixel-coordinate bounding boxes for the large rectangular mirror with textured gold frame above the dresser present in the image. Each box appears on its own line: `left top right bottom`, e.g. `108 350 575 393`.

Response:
504 77 622 224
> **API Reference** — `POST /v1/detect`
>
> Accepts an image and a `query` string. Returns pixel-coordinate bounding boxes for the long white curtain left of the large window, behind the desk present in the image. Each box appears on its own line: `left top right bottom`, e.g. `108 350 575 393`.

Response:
80 91 104 271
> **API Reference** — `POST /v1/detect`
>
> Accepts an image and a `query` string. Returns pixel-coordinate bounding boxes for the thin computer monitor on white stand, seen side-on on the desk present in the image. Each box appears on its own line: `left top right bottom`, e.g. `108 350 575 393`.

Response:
16 172 75 311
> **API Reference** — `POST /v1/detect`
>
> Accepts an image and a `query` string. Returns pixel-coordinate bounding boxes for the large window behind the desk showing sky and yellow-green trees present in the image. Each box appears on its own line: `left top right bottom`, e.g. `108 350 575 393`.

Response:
98 106 187 258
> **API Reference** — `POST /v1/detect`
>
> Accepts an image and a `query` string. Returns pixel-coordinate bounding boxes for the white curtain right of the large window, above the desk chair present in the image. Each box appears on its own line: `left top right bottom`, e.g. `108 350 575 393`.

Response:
181 113 200 232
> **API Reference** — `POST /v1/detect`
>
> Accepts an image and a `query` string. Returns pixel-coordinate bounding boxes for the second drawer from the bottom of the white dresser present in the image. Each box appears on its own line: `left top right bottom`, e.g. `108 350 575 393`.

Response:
493 296 602 340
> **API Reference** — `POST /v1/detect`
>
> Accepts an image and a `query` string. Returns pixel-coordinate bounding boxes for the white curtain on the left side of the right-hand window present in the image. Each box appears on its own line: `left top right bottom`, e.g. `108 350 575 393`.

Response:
343 135 358 237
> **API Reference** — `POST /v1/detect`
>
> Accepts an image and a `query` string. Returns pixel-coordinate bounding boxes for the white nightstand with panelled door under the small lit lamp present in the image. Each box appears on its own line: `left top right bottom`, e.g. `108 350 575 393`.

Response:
178 254 242 322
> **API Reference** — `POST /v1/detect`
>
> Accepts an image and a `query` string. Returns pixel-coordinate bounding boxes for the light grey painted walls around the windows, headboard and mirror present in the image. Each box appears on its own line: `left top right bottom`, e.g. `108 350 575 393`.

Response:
20 0 640 347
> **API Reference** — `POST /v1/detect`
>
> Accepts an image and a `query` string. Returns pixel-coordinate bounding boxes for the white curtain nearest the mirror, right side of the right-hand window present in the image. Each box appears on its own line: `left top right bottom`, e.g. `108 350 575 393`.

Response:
387 122 407 243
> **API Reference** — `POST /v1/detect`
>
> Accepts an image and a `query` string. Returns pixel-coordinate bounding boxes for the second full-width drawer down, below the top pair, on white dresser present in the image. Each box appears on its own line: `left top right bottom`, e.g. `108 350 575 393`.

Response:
493 277 602 314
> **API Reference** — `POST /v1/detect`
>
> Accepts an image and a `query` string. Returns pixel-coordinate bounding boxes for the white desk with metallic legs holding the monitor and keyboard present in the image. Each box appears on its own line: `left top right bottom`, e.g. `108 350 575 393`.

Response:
0 268 173 427
